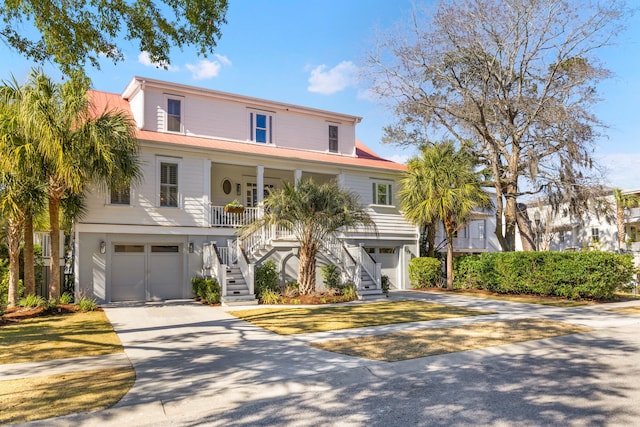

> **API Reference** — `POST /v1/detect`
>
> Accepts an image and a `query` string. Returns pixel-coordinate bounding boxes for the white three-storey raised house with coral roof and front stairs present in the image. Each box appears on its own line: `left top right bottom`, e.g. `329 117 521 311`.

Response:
74 77 418 304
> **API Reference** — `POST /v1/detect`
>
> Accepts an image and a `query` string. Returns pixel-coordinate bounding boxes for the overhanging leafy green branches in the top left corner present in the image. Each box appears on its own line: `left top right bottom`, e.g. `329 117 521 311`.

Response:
0 0 228 74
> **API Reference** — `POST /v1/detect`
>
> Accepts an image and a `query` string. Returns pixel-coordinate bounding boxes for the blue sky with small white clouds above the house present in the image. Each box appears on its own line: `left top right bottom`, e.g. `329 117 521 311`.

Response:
0 0 640 189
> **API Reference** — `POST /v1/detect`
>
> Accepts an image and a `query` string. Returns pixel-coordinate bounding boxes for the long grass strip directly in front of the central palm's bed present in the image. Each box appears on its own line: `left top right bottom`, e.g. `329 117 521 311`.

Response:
230 301 492 335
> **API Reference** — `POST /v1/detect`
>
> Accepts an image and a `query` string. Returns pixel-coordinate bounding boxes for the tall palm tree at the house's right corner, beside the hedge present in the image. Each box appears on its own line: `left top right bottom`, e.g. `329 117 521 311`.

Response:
399 142 490 288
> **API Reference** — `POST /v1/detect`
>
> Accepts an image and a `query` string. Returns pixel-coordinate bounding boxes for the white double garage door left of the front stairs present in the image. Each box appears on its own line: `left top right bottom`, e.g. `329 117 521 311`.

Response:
111 244 183 301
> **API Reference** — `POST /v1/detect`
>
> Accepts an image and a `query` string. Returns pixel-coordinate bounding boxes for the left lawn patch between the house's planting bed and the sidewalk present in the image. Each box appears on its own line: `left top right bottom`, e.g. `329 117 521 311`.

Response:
0 311 123 364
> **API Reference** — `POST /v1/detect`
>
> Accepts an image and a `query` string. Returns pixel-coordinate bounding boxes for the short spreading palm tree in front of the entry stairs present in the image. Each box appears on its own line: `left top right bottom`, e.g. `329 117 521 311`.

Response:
243 179 375 295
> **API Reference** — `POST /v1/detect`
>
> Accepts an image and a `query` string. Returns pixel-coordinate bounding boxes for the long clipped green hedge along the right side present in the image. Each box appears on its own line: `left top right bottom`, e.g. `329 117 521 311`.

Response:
454 251 634 300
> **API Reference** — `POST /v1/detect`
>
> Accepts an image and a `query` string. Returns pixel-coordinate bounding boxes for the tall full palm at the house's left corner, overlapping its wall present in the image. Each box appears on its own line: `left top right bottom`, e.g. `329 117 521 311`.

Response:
6 70 141 298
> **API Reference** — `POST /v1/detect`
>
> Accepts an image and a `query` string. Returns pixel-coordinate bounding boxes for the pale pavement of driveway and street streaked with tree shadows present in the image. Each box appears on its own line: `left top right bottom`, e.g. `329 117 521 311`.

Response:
23 292 640 426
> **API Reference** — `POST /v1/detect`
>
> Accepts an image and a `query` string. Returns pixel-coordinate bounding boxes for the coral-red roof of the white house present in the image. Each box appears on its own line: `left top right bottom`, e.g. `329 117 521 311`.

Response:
89 90 406 171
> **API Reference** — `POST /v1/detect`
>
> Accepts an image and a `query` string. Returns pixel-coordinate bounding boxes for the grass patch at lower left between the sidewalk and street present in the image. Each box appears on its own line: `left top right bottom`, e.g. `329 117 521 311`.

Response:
0 368 135 425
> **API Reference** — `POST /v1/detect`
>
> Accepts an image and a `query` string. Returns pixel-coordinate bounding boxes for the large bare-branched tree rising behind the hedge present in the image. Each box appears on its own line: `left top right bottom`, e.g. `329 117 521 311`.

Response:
368 0 624 251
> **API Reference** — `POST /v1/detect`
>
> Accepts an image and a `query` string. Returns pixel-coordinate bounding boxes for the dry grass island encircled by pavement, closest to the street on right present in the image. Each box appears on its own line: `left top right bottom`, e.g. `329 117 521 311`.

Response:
310 319 591 362
